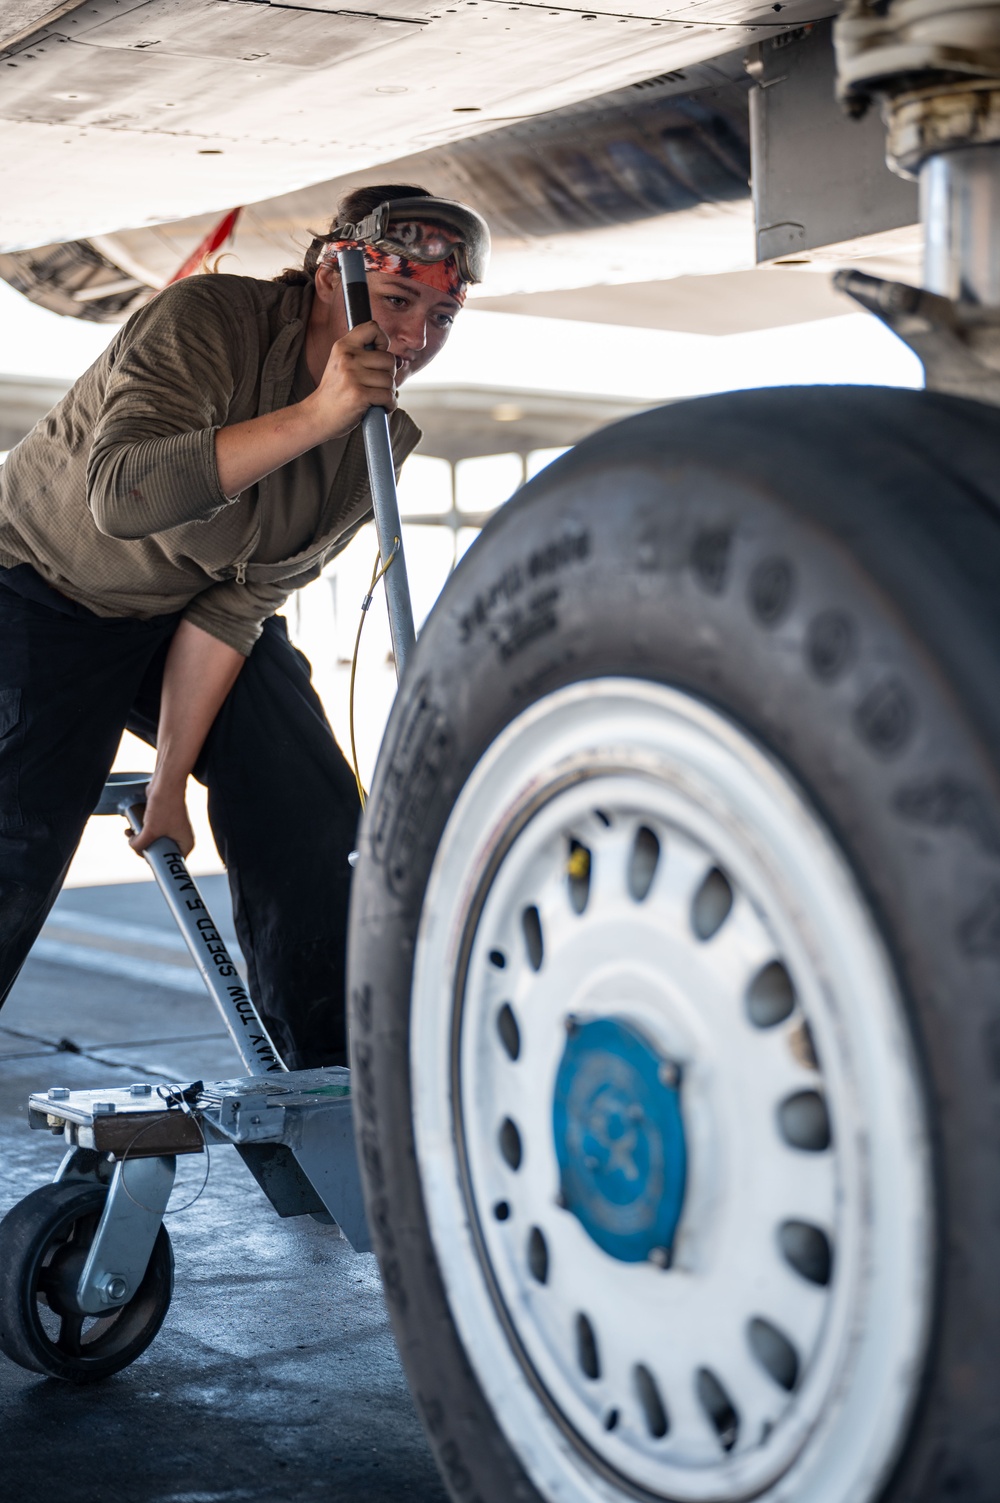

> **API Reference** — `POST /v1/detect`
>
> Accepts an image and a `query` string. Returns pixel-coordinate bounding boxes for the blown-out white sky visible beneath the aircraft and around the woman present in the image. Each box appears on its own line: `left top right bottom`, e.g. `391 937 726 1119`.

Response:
0 273 923 885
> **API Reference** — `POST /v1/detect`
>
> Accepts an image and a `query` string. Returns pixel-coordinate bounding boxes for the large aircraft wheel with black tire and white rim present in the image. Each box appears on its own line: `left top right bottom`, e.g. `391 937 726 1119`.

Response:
349 388 1000 1503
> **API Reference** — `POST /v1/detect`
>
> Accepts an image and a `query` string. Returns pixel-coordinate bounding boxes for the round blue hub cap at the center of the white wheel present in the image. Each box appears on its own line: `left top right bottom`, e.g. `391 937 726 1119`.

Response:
552 1018 687 1264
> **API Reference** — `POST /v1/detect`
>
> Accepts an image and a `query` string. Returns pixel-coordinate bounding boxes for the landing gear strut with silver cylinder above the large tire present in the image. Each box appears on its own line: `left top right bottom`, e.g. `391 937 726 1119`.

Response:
835 0 1000 404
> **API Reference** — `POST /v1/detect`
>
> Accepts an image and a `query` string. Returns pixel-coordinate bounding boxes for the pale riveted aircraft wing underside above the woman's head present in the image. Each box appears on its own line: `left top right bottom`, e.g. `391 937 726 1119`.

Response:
0 0 830 249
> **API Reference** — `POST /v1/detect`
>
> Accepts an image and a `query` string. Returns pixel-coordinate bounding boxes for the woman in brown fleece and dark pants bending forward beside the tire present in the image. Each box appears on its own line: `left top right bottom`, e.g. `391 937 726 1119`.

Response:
0 185 489 1069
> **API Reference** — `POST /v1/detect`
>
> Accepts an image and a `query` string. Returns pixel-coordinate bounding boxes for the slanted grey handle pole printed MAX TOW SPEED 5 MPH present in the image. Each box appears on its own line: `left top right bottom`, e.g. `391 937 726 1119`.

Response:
122 791 286 1075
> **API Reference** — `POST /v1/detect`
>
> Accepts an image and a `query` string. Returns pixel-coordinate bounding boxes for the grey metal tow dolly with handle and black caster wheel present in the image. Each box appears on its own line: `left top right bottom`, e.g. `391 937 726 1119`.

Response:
0 773 371 1383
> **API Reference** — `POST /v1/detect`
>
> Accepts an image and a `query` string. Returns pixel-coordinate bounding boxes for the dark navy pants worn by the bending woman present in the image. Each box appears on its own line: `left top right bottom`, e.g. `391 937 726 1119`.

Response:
0 565 359 1069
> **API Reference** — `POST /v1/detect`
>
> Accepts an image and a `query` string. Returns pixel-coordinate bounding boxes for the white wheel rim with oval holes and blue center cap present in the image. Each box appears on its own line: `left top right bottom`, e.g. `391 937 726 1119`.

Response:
411 679 931 1503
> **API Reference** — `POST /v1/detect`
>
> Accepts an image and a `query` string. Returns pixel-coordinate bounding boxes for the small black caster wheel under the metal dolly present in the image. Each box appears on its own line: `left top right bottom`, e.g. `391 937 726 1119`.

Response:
0 1183 173 1383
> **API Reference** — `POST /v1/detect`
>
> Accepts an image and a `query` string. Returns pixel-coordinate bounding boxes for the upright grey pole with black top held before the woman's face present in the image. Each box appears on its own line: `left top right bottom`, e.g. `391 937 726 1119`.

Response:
337 249 417 679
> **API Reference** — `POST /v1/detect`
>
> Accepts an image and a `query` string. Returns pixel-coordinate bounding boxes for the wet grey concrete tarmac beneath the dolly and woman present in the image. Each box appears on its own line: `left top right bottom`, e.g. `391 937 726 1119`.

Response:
0 878 447 1503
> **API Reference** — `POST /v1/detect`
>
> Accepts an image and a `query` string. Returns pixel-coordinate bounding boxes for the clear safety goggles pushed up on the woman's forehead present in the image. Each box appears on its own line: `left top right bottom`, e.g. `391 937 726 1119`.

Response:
334 198 490 283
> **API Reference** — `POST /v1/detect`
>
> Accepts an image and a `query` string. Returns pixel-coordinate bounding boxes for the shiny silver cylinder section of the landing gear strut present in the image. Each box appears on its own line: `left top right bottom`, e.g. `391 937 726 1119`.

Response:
920 143 1000 308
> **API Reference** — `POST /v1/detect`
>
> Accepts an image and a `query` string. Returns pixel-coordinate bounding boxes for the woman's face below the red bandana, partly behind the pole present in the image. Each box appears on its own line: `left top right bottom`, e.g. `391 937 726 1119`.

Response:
316 262 462 378
